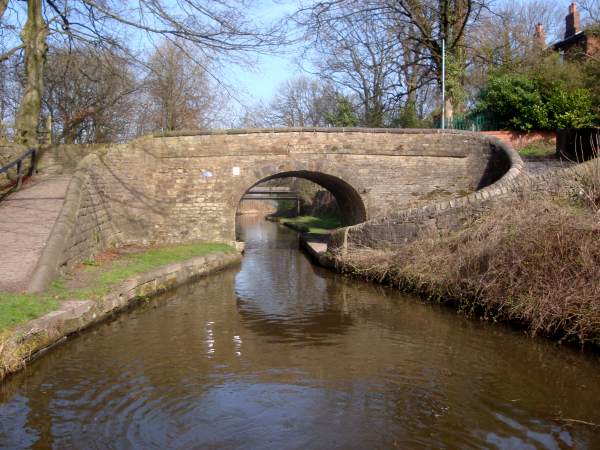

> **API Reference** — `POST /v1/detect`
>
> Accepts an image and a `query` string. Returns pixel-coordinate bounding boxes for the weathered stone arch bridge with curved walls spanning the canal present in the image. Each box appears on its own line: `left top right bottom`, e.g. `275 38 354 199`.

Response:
3 128 520 285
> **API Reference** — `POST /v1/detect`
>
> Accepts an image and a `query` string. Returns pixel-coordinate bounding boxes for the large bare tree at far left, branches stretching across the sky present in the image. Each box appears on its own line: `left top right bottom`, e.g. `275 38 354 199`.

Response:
0 0 281 145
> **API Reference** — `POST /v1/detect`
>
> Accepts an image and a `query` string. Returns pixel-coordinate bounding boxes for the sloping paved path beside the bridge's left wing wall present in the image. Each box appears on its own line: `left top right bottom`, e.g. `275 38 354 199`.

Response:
0 175 71 292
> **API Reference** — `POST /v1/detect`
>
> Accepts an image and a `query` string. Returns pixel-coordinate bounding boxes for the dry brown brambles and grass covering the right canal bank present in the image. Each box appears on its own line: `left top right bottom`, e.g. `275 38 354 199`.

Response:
344 195 600 344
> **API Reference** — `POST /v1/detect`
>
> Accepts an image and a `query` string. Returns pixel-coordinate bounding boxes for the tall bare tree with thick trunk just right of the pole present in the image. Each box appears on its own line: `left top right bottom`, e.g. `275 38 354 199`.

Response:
297 0 490 121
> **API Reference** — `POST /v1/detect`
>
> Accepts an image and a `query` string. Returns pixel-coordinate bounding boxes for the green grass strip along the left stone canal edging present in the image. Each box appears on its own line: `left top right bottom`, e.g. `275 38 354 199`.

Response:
0 243 234 332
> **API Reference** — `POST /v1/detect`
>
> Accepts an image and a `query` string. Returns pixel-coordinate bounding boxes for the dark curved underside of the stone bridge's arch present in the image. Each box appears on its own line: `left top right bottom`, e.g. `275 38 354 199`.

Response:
238 170 367 226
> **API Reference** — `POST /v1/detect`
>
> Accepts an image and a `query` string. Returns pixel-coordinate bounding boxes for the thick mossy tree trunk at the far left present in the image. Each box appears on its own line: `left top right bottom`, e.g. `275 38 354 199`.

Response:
15 0 48 147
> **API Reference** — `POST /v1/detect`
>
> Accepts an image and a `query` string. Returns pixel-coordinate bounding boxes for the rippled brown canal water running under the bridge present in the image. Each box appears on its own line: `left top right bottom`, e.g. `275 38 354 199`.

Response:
0 217 600 449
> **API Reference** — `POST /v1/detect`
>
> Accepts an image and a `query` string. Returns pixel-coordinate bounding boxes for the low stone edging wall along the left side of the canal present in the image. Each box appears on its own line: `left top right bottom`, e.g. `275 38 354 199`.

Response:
0 248 241 381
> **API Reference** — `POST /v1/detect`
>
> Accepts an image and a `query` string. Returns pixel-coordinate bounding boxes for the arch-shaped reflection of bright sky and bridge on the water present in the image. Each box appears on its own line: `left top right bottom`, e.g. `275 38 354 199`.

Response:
235 216 352 345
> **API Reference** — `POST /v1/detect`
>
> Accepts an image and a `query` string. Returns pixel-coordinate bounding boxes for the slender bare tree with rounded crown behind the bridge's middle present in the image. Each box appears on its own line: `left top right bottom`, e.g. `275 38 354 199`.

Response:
298 1 401 127
